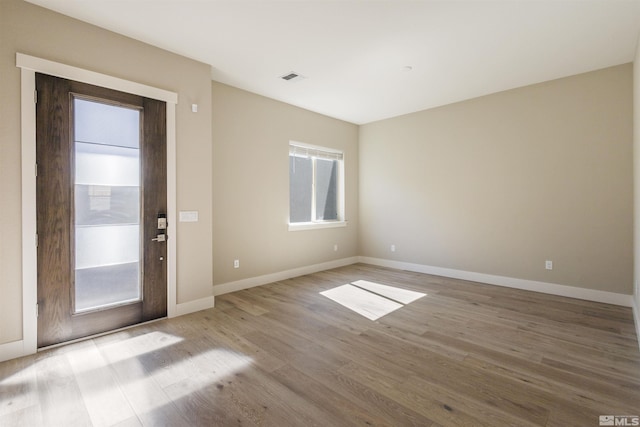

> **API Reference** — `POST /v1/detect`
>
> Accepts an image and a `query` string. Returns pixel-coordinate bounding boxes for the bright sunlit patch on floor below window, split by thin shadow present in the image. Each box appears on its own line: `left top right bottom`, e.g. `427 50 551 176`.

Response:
320 280 426 320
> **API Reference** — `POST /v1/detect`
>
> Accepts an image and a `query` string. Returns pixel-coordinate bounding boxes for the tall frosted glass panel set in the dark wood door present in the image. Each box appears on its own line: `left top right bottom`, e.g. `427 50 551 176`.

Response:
73 98 142 313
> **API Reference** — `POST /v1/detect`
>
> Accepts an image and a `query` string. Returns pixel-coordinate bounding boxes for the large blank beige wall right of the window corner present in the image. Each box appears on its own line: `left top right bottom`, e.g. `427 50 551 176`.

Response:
359 64 633 294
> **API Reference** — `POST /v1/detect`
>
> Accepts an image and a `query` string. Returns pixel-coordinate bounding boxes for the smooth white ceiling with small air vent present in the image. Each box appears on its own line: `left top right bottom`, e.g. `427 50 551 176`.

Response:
28 0 640 124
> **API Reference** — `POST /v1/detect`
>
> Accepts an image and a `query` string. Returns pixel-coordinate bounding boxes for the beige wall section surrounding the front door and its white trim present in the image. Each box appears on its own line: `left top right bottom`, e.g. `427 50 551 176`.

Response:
0 0 213 344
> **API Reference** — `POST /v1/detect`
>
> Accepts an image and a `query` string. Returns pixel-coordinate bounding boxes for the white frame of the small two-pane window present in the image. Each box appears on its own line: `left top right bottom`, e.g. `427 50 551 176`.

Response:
289 141 347 231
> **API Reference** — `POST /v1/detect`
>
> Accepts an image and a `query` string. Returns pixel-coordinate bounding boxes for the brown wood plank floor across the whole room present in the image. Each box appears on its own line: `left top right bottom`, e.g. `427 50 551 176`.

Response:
0 264 640 427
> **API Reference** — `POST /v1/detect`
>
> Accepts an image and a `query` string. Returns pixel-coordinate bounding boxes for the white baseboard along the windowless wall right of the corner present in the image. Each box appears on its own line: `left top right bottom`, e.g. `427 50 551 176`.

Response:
359 257 638 308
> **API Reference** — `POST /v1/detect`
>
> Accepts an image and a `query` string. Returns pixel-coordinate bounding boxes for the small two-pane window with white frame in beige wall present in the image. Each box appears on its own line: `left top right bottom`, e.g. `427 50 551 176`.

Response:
289 143 345 230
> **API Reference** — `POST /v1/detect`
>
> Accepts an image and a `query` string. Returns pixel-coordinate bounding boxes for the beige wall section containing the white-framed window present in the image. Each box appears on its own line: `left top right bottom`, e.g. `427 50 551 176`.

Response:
212 82 358 285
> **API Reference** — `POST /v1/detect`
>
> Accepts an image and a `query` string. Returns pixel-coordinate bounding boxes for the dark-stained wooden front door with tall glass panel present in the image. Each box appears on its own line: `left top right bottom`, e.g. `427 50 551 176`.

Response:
36 74 167 347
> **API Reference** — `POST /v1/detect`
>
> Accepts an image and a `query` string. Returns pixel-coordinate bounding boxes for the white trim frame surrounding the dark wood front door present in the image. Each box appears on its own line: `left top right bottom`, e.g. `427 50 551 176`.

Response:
16 53 178 356
